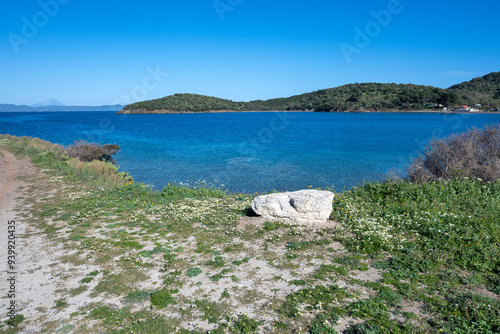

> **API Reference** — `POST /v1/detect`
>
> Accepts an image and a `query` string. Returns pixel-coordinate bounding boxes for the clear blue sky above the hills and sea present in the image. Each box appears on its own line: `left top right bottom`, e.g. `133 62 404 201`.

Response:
0 0 500 105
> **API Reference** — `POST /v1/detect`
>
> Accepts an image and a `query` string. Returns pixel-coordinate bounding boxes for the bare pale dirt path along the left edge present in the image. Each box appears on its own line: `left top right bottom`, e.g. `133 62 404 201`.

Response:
0 151 60 332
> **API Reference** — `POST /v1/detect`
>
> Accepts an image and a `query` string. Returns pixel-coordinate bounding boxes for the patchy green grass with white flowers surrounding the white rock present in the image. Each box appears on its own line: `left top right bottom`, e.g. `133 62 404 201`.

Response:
0 136 500 334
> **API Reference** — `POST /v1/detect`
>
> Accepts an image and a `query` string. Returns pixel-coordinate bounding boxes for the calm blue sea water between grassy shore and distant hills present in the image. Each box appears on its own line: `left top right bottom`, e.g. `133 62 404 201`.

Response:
0 112 500 193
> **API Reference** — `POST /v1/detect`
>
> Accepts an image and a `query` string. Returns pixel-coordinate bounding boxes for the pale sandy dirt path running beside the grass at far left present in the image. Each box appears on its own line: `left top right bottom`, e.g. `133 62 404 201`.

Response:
0 150 89 333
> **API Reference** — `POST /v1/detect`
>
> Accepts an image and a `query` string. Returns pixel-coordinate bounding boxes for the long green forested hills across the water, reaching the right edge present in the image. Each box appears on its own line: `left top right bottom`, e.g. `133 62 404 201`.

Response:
120 72 500 113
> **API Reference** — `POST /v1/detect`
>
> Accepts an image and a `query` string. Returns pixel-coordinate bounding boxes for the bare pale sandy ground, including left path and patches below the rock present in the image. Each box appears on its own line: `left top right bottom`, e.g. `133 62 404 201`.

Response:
0 150 380 333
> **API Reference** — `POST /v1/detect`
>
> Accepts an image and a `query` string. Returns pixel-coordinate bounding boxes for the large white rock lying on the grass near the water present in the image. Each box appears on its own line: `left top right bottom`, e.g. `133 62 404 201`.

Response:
252 189 335 224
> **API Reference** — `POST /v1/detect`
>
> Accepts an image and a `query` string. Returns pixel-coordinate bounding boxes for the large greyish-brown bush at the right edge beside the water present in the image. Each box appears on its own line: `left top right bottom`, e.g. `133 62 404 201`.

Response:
407 124 500 182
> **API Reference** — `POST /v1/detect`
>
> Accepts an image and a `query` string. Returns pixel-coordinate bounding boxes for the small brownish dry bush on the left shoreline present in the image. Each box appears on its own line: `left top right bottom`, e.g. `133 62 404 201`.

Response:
66 139 120 163
